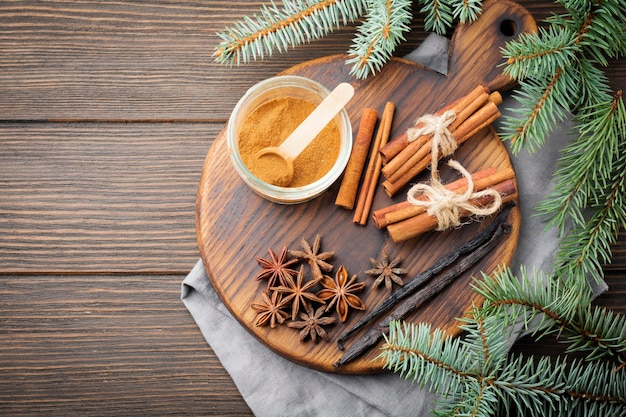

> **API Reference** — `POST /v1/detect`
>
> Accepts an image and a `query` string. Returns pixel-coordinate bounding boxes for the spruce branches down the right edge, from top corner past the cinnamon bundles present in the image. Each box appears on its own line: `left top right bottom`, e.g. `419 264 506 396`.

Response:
502 0 626 282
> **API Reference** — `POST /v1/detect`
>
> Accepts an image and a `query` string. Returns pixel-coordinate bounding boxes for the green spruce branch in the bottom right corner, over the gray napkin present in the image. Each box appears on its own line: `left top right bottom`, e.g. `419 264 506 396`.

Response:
379 270 626 417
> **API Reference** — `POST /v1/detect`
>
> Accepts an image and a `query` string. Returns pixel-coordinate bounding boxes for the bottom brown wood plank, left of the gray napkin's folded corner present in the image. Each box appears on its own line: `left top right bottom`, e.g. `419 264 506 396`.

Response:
0 275 251 416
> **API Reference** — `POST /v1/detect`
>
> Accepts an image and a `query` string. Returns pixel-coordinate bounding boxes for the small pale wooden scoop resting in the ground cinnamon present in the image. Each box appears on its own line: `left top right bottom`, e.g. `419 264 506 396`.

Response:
255 83 354 187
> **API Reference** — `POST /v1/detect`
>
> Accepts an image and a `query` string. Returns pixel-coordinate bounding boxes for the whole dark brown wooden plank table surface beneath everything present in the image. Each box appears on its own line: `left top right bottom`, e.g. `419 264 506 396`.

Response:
0 0 626 416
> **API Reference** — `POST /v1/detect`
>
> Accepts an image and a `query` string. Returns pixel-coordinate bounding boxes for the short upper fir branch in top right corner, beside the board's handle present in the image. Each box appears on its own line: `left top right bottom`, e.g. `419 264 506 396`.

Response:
502 0 626 153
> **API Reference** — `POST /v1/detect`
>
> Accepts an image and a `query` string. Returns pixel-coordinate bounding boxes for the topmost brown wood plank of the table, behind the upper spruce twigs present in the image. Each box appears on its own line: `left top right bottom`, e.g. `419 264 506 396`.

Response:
0 0 626 121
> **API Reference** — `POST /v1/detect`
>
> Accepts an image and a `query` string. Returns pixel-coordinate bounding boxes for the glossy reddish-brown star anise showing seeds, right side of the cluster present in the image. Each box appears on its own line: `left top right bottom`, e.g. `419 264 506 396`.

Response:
317 265 365 322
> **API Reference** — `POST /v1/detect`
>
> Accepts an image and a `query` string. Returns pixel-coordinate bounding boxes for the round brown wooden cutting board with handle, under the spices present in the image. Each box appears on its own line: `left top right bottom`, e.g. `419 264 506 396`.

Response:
196 1 536 373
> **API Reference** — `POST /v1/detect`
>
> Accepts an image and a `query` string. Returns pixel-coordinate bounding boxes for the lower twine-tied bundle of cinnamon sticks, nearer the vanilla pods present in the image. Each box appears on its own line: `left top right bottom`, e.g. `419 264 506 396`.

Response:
372 168 517 242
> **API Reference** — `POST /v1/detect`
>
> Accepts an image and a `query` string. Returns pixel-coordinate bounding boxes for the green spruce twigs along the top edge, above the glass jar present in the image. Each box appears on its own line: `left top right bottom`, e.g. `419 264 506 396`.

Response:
213 0 482 79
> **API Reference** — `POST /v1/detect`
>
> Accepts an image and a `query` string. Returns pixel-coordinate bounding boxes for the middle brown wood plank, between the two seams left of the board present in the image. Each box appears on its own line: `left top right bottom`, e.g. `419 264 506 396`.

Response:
0 123 214 274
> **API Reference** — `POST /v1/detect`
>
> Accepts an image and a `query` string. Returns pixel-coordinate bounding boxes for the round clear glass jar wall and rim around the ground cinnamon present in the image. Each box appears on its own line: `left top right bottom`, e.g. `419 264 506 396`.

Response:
226 75 352 204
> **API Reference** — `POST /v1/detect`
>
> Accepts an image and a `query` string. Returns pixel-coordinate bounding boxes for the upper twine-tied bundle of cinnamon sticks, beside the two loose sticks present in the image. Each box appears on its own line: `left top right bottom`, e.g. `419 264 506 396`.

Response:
380 84 502 197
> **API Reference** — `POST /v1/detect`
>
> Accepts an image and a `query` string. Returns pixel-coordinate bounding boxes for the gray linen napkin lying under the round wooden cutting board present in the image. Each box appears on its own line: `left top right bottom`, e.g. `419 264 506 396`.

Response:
182 35 605 417
